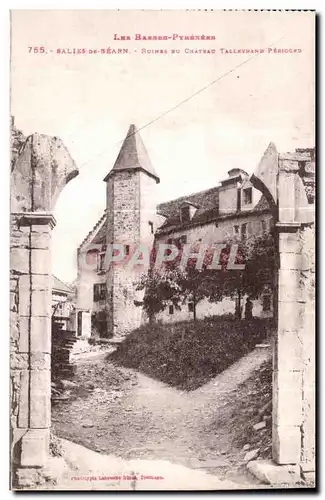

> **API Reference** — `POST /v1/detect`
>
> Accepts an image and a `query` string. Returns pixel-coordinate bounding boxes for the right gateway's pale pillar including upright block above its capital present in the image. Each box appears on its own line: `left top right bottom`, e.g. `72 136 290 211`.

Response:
273 153 314 465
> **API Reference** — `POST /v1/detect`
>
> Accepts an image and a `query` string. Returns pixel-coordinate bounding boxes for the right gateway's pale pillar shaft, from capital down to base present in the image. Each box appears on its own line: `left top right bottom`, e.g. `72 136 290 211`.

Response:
272 223 302 465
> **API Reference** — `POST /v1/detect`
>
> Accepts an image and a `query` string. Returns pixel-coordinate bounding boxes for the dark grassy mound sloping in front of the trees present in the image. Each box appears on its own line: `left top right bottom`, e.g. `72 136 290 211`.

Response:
108 316 271 391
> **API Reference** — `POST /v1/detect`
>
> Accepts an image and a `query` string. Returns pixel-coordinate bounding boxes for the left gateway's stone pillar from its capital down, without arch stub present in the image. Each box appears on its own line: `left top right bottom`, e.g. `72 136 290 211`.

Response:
11 212 55 475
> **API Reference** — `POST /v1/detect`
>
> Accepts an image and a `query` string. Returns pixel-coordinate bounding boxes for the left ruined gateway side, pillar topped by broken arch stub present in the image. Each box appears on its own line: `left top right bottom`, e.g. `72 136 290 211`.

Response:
10 126 78 488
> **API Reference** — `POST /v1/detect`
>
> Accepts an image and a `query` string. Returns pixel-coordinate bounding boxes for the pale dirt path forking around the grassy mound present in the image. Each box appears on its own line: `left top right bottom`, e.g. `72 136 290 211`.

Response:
52 349 270 484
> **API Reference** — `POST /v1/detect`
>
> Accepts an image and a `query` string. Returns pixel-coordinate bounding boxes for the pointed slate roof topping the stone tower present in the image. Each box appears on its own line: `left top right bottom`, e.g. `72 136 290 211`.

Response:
104 125 160 183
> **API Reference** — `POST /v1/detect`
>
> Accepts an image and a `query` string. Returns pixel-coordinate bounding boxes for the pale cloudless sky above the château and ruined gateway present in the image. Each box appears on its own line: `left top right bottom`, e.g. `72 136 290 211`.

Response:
11 10 315 282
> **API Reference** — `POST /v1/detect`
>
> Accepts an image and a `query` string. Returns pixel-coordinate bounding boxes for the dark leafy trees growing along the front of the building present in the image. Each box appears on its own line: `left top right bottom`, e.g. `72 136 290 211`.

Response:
137 234 275 320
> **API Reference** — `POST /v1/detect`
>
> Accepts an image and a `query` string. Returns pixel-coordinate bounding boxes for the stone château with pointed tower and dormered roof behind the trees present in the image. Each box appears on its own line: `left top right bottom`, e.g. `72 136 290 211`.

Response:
77 125 274 338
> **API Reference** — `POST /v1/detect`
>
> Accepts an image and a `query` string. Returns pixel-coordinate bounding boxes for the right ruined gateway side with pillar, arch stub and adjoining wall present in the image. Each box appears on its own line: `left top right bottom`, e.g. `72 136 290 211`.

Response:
251 144 315 481
